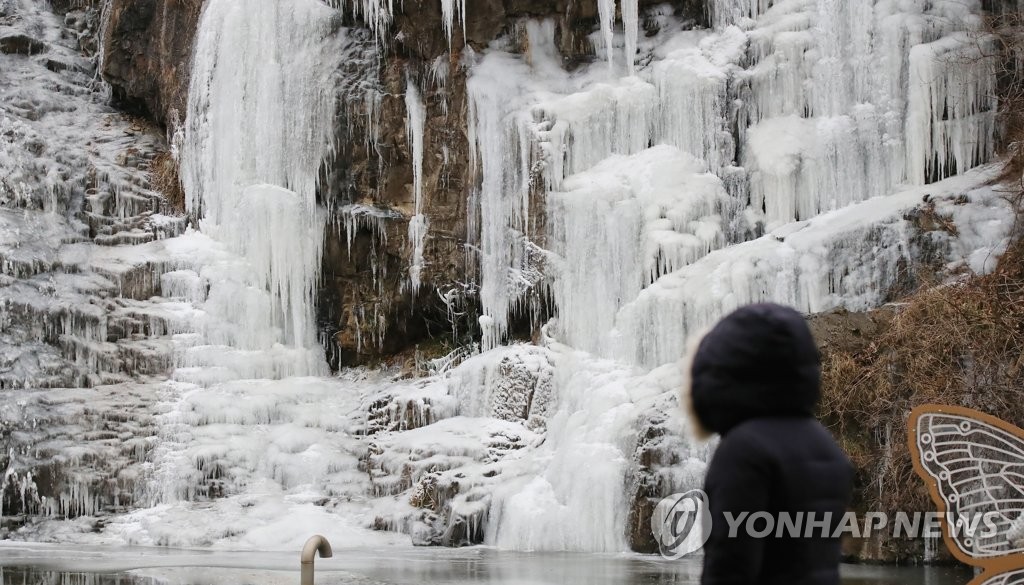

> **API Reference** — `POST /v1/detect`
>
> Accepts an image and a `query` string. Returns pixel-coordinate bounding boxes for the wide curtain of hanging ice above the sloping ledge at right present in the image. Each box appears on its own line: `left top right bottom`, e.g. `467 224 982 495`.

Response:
470 0 995 366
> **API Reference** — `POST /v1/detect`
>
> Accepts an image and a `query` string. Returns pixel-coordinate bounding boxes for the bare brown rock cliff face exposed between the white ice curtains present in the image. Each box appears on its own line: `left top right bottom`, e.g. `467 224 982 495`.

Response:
102 0 707 367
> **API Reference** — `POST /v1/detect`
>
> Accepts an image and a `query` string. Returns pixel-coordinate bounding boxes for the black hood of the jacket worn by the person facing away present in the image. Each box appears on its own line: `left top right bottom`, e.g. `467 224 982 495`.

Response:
689 303 821 434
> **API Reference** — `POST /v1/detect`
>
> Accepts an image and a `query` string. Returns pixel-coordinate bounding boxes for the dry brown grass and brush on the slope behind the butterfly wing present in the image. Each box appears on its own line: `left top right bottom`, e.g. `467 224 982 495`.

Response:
821 234 1024 532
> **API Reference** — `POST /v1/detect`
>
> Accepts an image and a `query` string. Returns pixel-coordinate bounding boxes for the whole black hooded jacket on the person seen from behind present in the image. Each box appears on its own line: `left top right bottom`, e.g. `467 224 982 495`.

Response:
690 304 853 585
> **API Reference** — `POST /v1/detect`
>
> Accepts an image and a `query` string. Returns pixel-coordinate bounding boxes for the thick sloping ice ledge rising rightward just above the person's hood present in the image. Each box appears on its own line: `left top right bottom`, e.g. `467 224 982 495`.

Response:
611 172 1007 366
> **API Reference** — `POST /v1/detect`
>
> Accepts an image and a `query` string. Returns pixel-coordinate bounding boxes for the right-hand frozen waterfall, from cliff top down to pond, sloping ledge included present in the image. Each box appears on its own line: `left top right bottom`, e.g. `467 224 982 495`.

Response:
469 0 1006 550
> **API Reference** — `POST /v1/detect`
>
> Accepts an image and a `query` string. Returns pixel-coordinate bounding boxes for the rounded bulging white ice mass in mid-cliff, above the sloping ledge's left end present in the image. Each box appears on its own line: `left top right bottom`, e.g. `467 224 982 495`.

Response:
547 145 727 354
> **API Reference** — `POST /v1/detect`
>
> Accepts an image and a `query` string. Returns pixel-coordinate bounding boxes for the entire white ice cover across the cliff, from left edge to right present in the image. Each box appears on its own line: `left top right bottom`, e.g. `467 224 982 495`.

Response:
0 0 1011 551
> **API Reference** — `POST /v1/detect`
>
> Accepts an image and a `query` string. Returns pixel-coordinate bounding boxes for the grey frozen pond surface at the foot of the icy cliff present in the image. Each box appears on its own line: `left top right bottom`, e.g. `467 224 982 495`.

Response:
0 543 970 585
